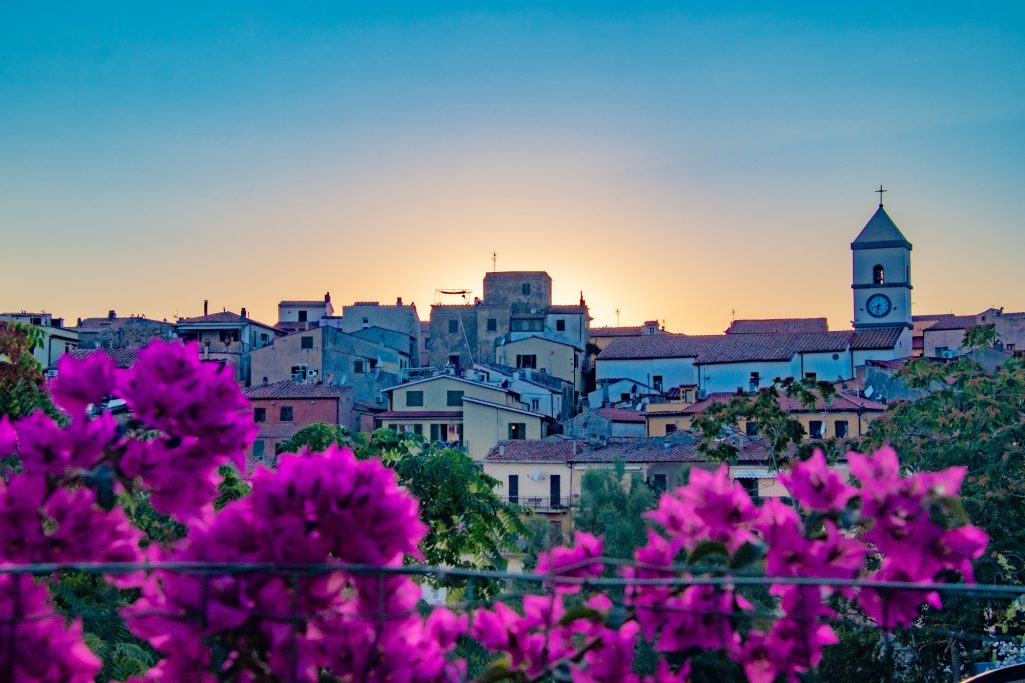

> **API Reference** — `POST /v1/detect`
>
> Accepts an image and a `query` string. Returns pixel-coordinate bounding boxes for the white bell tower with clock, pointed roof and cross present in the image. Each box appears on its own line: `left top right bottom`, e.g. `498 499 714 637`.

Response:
851 186 911 329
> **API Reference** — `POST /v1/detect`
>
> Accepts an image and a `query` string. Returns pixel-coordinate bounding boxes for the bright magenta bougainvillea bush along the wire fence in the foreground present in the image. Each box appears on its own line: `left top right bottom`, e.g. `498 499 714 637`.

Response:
0 343 986 683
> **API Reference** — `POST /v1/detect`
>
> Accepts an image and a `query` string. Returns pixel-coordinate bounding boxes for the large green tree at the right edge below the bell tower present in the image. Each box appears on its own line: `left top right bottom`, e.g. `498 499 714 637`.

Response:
861 352 1025 670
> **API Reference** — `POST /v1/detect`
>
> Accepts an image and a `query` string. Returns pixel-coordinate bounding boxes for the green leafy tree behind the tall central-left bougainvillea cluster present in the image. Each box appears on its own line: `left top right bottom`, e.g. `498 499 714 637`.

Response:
277 424 530 569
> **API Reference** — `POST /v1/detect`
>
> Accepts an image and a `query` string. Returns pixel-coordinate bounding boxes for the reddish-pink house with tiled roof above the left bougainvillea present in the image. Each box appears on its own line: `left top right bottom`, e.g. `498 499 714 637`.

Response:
243 380 360 469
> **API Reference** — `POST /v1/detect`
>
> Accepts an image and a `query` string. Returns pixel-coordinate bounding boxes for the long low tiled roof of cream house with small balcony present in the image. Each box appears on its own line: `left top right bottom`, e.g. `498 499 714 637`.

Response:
485 431 769 464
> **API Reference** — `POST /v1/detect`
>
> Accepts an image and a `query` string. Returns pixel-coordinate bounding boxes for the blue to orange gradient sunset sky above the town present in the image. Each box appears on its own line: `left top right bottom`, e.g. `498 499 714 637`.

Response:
0 0 1025 332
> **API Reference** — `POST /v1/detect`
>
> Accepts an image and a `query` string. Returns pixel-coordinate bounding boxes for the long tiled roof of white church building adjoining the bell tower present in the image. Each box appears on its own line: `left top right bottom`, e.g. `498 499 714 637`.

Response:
598 327 903 365
